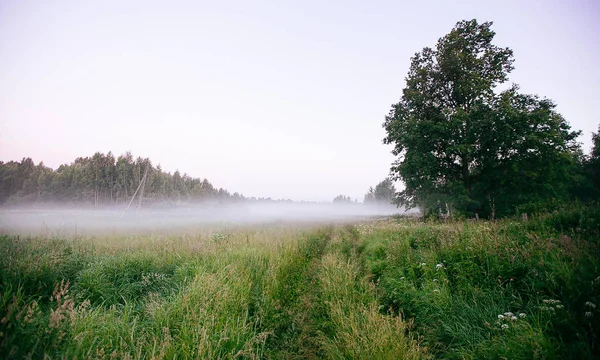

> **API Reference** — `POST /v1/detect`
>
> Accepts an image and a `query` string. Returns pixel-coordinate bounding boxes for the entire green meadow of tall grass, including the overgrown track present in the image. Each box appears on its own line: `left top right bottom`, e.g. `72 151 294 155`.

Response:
0 209 600 359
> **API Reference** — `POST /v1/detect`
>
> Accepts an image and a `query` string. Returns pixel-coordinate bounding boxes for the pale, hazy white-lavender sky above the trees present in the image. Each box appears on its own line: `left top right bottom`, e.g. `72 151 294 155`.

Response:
0 0 600 200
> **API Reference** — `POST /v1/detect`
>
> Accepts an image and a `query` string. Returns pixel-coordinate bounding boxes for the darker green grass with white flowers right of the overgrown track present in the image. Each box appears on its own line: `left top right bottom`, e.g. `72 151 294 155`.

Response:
362 209 600 359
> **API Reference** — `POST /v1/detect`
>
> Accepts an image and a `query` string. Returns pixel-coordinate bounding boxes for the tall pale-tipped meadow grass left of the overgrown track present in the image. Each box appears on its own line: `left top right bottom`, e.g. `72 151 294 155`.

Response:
0 228 305 358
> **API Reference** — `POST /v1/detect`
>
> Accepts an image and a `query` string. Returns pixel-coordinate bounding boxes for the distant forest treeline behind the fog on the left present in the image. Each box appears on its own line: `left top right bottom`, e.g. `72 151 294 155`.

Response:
0 152 252 206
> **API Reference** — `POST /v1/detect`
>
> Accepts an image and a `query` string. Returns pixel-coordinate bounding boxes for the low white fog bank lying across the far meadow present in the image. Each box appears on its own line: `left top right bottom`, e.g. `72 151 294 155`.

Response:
0 203 409 237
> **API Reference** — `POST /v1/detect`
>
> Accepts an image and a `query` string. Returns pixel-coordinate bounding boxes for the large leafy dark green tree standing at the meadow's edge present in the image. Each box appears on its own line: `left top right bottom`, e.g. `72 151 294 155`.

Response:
383 20 579 216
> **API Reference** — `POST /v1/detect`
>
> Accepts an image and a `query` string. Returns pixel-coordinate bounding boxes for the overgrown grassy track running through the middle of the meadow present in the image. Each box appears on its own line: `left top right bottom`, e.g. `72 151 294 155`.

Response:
265 226 424 359
